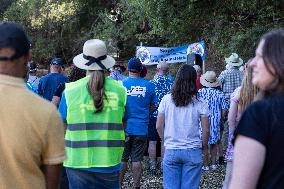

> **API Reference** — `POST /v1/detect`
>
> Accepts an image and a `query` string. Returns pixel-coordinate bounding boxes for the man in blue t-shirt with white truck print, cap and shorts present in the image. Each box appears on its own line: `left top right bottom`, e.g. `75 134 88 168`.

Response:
120 58 155 188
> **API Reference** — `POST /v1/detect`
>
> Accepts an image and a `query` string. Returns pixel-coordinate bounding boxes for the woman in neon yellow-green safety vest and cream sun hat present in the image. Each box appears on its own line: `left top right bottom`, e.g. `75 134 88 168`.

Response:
59 39 126 189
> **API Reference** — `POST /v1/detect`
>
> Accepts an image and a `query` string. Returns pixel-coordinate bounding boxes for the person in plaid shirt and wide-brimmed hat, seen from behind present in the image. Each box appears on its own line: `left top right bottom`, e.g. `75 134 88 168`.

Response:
218 53 244 102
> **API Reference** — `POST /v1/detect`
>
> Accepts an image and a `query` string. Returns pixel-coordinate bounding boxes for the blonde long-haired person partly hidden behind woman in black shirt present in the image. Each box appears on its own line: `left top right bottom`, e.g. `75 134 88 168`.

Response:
223 64 259 189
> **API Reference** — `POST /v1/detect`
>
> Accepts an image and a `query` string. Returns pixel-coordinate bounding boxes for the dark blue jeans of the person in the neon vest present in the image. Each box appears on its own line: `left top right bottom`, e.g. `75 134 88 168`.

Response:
66 168 119 189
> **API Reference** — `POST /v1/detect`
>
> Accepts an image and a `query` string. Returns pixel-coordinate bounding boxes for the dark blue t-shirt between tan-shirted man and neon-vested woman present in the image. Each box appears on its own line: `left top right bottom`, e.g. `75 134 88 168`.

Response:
38 73 68 101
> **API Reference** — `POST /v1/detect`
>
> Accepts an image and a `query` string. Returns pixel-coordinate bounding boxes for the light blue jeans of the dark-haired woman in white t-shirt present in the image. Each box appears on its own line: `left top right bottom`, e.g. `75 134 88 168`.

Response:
163 149 202 189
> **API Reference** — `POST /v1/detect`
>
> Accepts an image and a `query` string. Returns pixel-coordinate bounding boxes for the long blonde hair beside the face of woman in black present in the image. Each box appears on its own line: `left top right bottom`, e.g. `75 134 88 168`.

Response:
239 66 259 112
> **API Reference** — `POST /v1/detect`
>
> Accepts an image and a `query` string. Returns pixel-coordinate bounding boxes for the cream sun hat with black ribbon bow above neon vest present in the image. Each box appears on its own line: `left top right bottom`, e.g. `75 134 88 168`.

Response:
73 39 115 70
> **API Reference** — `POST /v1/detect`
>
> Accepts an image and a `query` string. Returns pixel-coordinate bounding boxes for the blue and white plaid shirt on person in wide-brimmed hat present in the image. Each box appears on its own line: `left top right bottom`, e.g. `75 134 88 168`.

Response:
218 67 244 99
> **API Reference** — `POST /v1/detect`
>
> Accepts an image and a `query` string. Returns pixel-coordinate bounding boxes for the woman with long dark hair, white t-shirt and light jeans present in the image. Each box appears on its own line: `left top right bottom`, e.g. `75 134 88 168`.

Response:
156 64 209 189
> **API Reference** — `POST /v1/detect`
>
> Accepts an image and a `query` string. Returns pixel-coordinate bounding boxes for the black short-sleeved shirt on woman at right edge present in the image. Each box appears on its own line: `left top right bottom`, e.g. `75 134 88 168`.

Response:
235 95 284 189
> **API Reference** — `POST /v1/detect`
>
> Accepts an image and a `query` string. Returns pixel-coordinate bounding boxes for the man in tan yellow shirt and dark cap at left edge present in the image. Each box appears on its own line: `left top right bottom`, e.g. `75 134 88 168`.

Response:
0 22 66 189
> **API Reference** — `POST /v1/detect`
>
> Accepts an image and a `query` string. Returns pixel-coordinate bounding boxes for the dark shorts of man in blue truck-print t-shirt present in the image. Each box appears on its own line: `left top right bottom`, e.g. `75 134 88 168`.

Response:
122 135 147 162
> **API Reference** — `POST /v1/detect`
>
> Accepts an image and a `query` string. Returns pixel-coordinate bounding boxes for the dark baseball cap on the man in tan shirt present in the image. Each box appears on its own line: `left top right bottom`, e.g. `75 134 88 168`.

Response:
0 22 31 61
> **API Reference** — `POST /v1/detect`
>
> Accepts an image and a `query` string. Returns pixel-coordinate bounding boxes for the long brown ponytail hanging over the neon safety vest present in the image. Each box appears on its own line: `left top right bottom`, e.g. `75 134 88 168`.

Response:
87 70 106 113
